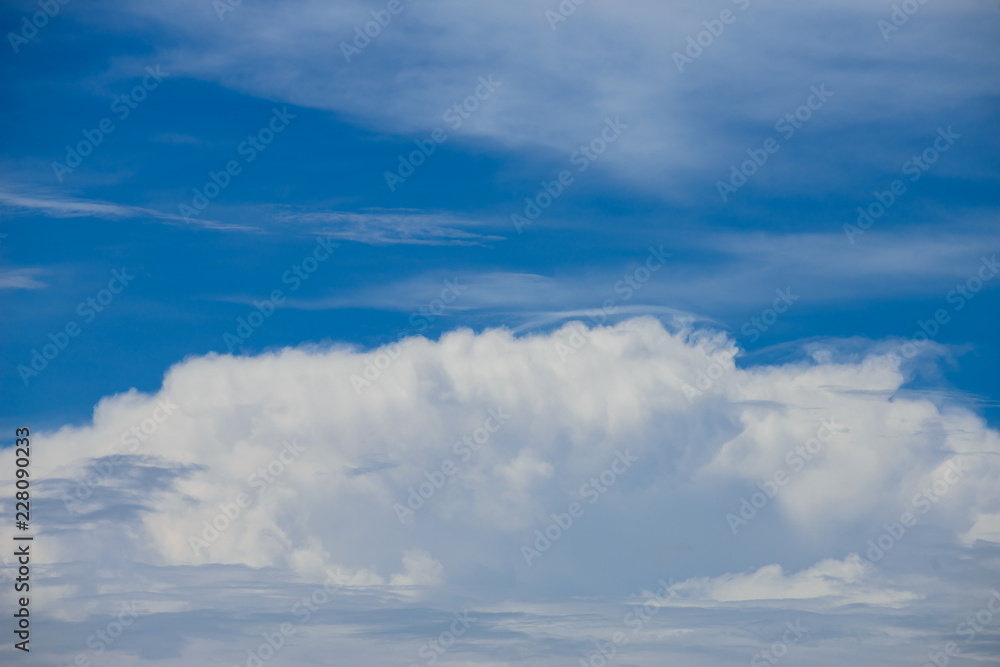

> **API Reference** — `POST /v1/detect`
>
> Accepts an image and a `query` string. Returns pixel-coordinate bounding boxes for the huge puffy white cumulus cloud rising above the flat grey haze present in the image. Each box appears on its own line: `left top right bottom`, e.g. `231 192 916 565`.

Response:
0 317 1000 664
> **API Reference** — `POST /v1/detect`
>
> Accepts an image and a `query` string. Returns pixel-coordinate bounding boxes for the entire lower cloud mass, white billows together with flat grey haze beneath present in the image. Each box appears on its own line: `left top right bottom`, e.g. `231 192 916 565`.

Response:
0 318 1000 665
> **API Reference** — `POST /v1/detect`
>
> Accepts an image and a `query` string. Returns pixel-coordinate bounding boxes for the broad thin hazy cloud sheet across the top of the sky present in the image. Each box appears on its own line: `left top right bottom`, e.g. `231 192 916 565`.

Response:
95 0 997 193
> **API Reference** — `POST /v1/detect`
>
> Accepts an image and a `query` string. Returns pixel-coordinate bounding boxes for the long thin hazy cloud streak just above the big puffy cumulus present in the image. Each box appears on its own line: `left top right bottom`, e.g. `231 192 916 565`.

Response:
270 231 1000 320
